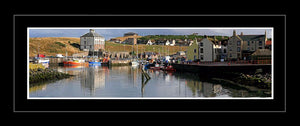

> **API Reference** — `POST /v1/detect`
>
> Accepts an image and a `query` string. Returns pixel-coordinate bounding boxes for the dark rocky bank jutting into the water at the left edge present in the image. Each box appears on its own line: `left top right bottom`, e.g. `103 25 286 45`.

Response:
29 68 72 83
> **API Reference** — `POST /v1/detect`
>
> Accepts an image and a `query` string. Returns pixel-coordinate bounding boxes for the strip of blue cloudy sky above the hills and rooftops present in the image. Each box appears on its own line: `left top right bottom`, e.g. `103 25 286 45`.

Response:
29 28 272 40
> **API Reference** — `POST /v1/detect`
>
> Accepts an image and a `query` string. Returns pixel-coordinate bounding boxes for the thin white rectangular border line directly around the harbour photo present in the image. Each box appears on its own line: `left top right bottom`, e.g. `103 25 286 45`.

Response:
27 27 274 100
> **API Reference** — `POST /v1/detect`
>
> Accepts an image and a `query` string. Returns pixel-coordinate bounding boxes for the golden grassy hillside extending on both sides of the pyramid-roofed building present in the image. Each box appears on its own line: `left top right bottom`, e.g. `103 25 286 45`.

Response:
29 37 187 57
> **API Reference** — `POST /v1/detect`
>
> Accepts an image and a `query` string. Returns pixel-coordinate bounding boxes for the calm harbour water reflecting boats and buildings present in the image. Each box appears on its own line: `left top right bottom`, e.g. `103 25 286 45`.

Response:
29 66 270 99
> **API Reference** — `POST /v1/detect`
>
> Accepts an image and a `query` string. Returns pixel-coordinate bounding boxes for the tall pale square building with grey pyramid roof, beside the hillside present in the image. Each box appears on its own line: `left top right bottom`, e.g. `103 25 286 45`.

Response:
80 29 105 51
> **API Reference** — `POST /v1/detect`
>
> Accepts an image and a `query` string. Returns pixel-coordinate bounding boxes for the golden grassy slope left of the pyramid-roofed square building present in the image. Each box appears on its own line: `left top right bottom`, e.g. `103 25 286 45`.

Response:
29 37 81 57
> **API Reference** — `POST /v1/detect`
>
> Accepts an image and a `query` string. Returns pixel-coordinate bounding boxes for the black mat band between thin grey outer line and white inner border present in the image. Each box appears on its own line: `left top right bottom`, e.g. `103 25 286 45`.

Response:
13 14 286 113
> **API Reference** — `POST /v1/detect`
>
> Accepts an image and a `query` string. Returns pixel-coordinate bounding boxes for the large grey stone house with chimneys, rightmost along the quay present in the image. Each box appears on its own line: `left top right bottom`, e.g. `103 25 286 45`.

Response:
227 30 267 60
